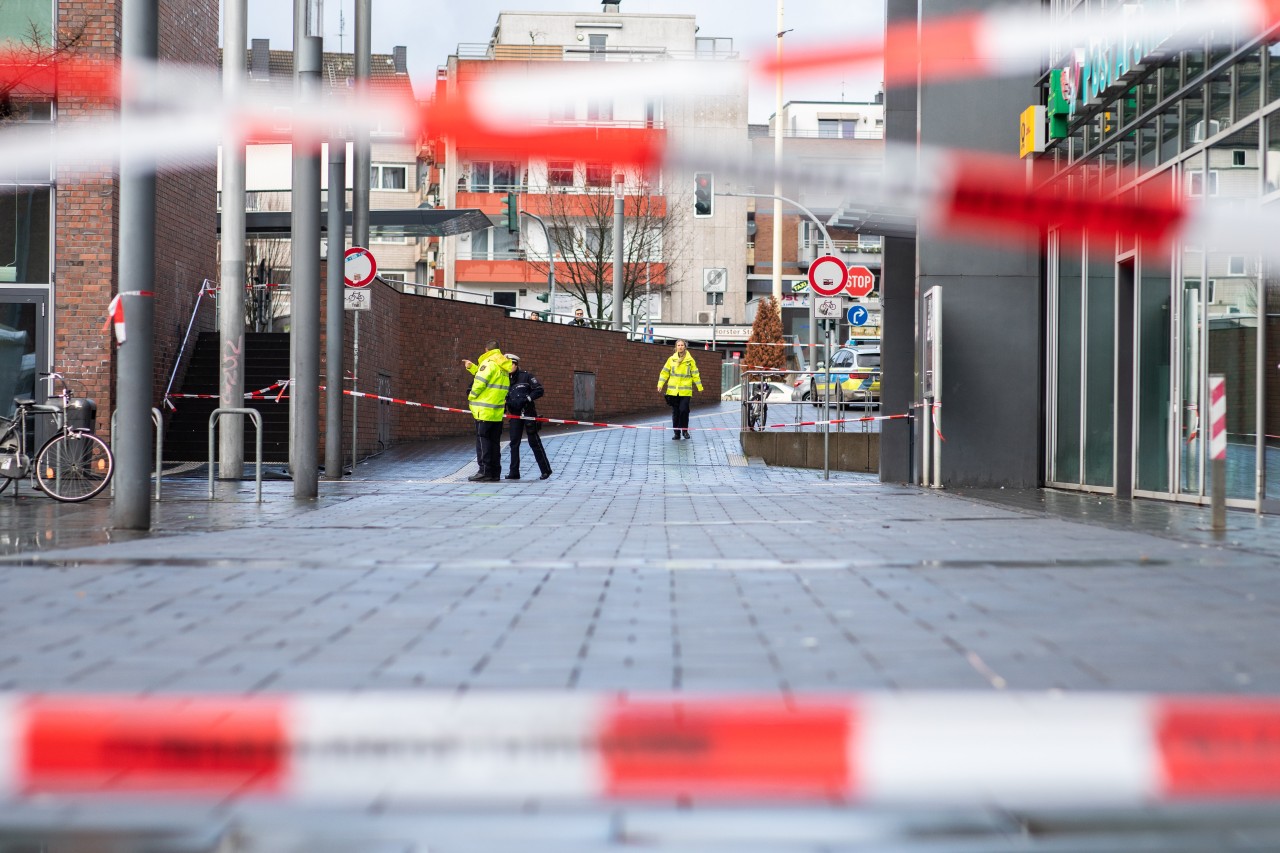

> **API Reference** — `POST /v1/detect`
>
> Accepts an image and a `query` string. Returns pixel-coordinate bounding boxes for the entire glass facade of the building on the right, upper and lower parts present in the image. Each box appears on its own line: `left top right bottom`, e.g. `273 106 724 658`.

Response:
1042 0 1280 511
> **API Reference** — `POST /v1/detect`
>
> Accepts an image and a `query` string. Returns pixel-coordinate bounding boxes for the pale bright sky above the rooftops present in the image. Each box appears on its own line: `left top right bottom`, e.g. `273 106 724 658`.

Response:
238 0 884 123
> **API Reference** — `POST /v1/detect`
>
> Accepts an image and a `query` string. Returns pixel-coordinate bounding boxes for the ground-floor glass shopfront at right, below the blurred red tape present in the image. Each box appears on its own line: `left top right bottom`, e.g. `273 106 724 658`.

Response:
1046 227 1280 511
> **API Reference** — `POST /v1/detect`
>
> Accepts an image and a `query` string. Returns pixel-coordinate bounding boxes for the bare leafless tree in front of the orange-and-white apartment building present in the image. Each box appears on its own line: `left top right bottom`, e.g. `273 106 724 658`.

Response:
530 168 689 324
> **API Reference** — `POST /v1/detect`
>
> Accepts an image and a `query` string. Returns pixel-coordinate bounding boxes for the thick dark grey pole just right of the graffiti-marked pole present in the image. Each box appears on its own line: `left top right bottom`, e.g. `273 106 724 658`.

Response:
289 6 321 498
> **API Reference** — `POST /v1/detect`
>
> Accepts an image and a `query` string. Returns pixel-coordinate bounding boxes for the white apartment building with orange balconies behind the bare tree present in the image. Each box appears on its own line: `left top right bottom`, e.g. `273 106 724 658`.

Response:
428 3 748 324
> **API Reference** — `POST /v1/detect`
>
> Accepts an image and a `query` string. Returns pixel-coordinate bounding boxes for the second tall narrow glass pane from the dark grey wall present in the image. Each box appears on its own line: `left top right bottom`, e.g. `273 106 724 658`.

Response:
1084 236 1116 487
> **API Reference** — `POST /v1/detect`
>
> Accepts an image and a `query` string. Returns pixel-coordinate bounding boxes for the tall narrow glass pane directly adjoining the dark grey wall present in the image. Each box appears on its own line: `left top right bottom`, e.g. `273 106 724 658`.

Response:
1053 230 1083 483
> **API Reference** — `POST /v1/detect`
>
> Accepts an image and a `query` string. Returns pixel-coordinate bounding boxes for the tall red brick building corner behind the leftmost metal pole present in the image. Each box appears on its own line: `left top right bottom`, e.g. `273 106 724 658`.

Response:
52 0 219 432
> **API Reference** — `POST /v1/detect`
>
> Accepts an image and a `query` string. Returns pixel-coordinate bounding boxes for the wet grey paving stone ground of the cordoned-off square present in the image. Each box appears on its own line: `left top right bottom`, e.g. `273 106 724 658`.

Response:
0 405 1280 693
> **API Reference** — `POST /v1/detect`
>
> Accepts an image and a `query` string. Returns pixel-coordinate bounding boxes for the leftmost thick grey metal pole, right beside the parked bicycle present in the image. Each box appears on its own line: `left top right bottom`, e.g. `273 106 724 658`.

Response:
111 0 159 530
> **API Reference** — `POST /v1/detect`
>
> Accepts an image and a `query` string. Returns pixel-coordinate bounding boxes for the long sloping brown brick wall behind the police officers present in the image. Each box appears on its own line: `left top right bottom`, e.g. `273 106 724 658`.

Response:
321 275 722 453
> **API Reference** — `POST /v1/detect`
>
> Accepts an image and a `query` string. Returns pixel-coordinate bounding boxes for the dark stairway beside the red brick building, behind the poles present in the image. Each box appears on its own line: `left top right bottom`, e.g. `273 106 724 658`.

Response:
164 332 289 474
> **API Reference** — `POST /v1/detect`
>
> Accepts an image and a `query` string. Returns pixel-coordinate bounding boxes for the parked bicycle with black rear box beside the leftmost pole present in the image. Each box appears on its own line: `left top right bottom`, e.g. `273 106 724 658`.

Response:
0 373 115 503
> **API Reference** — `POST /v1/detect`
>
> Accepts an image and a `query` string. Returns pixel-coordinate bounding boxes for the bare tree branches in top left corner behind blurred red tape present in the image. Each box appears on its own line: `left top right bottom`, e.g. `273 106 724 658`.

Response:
0 0 84 122
